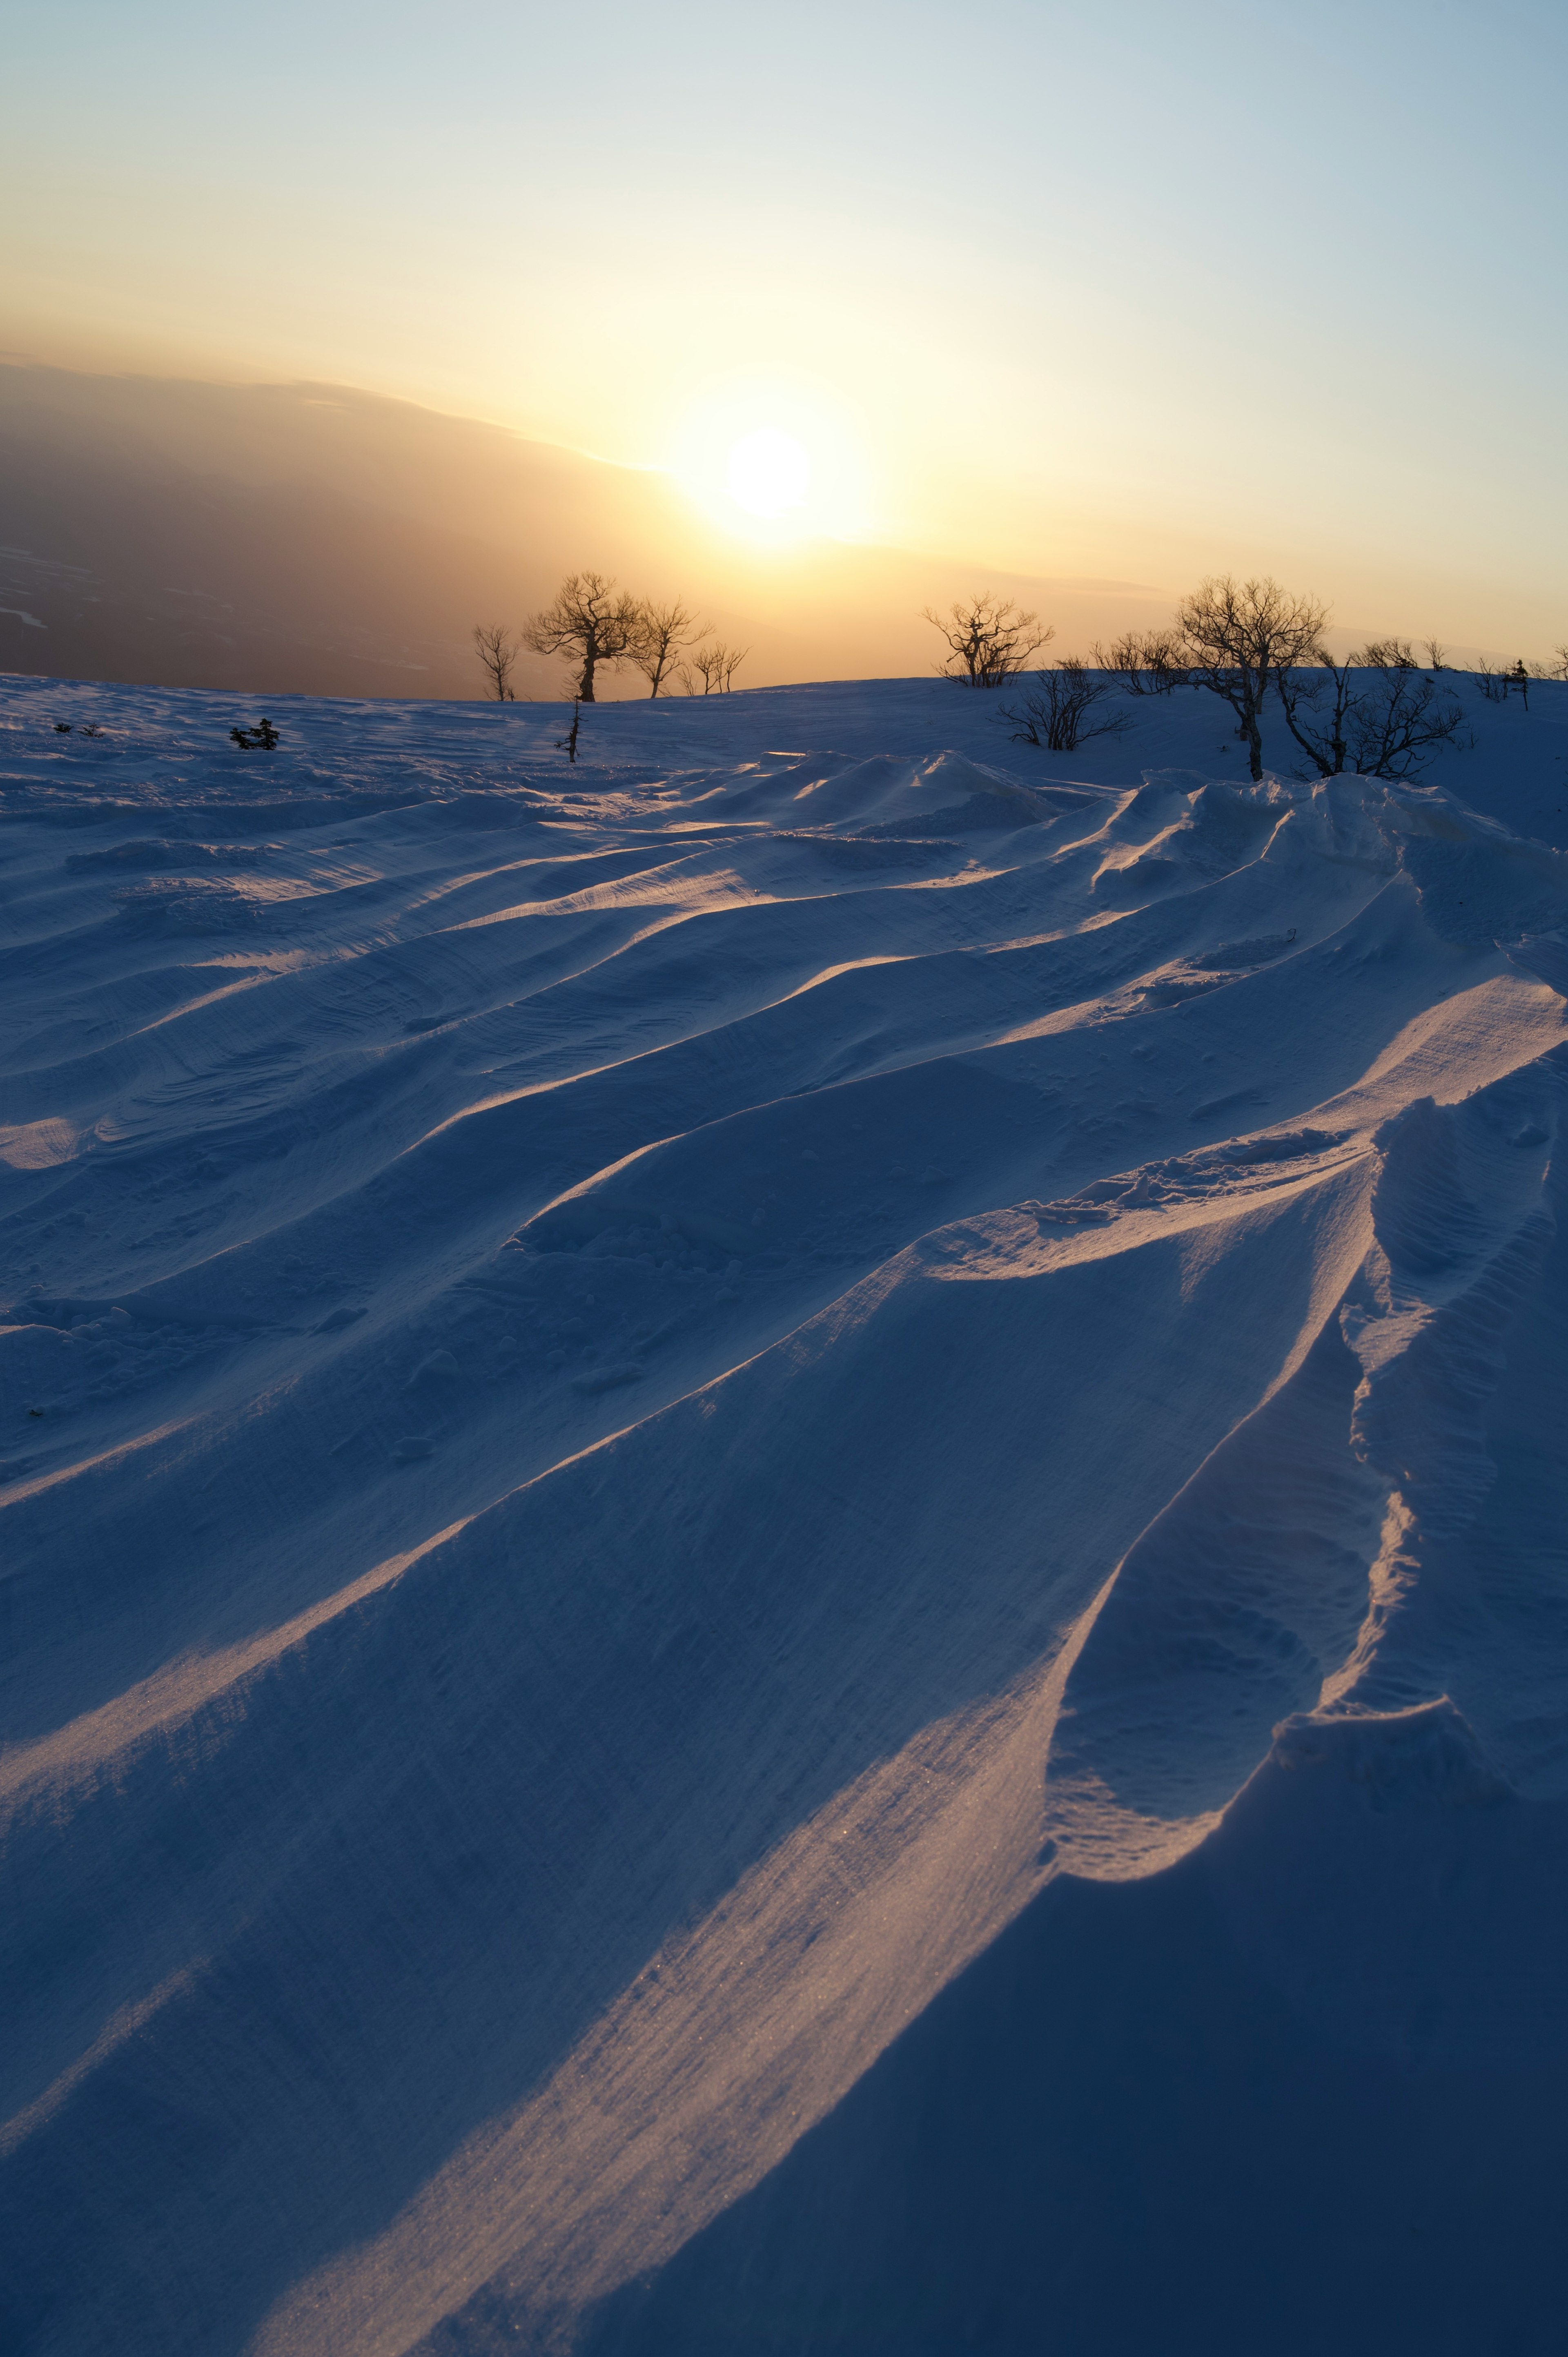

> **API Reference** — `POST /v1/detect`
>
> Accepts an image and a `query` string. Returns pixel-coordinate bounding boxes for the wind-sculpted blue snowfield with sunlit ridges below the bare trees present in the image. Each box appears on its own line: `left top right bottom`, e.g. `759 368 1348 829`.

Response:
0 681 1568 2357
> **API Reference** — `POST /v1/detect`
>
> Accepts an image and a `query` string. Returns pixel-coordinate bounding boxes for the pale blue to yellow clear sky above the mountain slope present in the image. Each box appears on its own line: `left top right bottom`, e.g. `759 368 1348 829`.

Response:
0 0 1568 653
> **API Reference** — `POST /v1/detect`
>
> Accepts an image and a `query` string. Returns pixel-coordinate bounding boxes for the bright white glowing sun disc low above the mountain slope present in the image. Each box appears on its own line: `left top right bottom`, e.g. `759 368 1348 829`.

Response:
667 372 870 547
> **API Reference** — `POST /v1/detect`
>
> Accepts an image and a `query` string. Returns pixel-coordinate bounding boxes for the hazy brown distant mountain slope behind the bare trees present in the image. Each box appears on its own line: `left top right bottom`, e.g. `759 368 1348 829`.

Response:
0 366 1165 698
